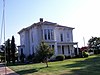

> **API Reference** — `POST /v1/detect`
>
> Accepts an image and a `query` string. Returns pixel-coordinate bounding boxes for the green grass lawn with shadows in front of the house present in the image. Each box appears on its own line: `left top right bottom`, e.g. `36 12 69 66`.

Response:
8 55 100 75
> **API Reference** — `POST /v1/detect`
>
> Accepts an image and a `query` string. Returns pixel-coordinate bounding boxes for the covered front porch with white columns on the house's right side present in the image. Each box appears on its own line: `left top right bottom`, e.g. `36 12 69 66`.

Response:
55 42 79 57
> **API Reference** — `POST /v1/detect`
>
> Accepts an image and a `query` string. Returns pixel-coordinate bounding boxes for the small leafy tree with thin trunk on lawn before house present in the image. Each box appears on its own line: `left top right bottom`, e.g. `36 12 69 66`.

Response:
36 42 54 67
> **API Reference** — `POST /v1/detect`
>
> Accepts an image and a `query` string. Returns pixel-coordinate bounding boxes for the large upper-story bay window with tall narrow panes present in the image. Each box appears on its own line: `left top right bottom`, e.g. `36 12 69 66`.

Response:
44 29 54 40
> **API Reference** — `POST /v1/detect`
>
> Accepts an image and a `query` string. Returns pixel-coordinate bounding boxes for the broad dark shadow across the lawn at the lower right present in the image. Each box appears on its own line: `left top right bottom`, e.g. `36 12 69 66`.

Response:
61 55 100 75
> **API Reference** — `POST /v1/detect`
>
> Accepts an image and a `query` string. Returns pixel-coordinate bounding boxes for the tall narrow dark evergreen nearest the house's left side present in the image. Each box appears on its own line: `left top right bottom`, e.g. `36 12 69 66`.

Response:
11 36 16 64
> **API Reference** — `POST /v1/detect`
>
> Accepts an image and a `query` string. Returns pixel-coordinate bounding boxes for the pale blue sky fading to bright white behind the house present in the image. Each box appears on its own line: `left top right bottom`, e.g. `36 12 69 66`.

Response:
0 0 100 47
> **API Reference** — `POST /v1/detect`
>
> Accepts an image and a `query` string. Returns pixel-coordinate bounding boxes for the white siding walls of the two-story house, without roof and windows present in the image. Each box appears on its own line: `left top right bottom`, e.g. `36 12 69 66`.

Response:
20 20 77 55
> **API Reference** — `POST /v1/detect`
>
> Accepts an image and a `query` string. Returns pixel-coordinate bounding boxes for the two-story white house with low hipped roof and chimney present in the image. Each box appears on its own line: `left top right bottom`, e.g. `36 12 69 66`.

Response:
18 18 79 56
